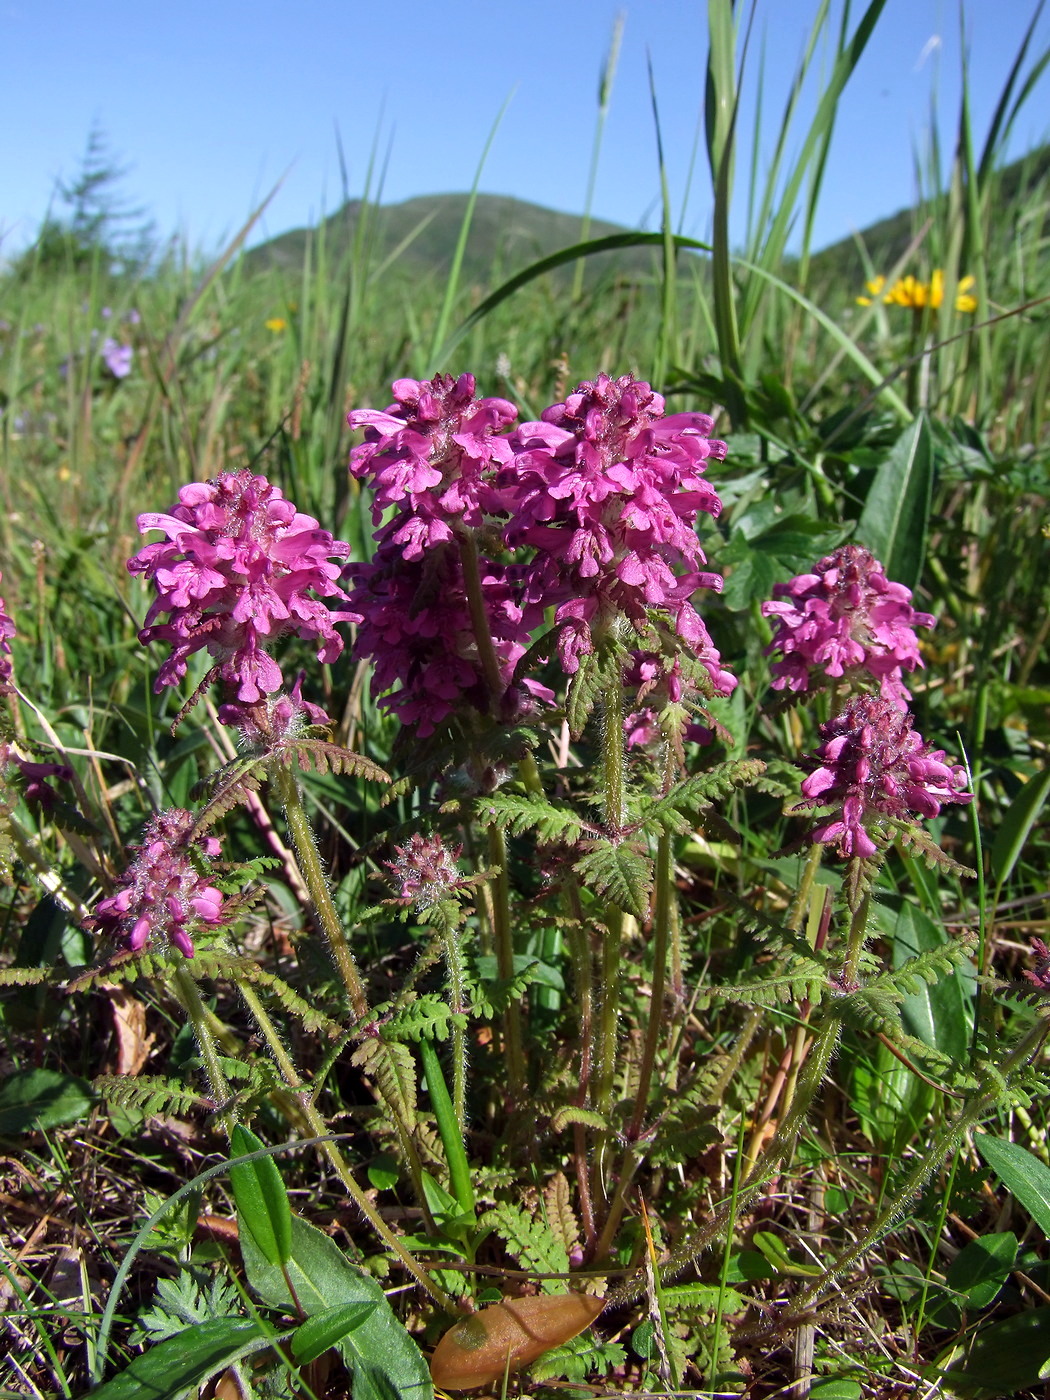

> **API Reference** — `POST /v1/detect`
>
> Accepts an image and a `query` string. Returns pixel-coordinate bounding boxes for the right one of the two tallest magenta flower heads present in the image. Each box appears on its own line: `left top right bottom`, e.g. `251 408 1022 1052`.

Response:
503 374 736 680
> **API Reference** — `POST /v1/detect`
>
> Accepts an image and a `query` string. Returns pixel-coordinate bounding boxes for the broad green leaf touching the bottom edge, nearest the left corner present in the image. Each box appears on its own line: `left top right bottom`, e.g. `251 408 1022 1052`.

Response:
91 1317 277 1400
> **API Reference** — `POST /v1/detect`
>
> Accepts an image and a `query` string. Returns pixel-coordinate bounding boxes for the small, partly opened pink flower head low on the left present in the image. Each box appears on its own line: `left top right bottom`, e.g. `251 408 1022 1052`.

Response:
91 806 224 958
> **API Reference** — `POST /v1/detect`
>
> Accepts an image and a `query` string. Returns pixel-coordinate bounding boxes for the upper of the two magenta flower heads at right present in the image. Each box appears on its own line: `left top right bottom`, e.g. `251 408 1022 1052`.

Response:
762 545 935 710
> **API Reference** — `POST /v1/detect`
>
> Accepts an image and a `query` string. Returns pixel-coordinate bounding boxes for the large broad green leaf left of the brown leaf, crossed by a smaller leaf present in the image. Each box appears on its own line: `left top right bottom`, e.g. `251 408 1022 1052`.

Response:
241 1215 434 1400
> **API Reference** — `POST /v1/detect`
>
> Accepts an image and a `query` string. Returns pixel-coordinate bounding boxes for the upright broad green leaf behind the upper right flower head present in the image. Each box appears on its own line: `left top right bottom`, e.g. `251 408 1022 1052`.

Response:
855 414 934 588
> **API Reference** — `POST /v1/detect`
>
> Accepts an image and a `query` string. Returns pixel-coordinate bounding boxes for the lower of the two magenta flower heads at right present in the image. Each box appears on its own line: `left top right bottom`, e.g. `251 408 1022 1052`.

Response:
802 694 972 857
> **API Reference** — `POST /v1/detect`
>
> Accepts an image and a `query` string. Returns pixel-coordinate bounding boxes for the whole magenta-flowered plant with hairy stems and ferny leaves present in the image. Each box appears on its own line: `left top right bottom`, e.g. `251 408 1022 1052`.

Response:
49 375 1043 1400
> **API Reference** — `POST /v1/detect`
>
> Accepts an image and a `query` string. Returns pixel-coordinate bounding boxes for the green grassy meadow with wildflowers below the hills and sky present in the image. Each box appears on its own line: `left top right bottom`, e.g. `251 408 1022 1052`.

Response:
0 0 1050 1400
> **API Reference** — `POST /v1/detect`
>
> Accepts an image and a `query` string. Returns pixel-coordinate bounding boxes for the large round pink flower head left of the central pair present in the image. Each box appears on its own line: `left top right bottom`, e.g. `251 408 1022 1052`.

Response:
127 469 358 704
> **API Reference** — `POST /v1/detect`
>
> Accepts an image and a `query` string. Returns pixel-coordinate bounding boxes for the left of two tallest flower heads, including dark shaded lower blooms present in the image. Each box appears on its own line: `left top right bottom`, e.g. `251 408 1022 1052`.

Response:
347 374 536 738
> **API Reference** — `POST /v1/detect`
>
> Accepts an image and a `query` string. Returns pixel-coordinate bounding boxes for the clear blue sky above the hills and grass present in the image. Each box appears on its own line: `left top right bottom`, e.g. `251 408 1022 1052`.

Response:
0 0 1050 256
